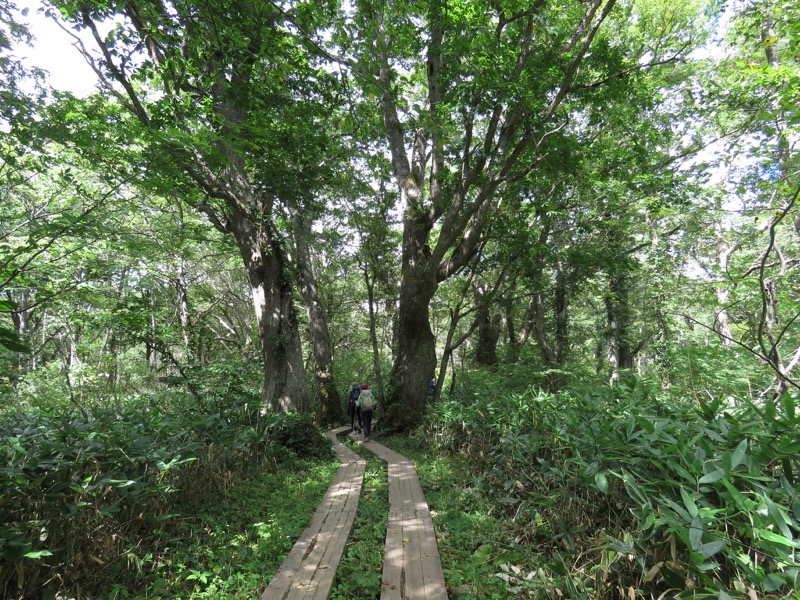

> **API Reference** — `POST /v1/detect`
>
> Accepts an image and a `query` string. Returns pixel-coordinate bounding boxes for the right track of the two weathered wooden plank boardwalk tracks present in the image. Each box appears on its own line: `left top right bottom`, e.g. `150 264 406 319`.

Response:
351 436 447 600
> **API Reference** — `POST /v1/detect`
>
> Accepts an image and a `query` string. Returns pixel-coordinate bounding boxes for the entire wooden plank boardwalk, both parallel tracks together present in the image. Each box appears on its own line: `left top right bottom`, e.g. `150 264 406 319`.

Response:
261 426 447 600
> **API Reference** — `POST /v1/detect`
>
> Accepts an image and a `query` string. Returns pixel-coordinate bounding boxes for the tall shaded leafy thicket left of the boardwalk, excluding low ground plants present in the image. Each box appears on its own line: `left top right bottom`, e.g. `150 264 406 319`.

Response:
0 398 329 596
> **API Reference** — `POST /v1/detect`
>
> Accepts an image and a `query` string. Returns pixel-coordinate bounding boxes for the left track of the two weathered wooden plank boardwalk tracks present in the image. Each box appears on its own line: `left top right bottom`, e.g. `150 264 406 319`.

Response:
261 426 366 600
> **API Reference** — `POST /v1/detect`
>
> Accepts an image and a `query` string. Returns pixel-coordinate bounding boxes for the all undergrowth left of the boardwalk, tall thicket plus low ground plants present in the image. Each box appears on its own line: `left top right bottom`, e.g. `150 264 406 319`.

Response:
0 397 339 599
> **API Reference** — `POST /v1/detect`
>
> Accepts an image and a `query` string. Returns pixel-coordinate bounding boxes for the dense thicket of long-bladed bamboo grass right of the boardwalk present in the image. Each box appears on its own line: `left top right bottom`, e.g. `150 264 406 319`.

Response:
427 380 800 598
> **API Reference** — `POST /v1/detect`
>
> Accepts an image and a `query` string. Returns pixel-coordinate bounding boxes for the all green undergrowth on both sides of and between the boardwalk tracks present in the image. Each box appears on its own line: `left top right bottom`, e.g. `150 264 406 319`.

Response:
0 374 800 600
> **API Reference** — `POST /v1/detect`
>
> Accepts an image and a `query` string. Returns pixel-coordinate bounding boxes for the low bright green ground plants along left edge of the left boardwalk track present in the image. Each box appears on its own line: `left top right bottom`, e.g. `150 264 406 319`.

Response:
105 458 339 600
